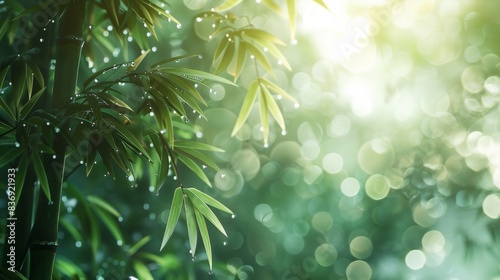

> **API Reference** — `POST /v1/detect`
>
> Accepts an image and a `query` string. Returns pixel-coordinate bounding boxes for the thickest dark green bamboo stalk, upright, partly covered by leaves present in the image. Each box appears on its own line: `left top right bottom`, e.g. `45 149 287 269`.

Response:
29 0 86 280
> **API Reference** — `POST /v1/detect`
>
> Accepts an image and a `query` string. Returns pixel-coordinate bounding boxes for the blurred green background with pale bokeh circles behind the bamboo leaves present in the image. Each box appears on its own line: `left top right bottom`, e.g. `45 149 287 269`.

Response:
1 0 500 280
